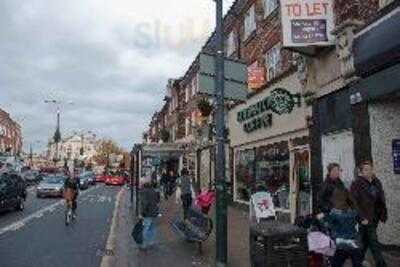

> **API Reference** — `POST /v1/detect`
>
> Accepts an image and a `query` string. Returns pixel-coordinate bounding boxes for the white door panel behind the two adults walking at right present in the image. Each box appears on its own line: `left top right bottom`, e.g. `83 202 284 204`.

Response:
322 130 355 187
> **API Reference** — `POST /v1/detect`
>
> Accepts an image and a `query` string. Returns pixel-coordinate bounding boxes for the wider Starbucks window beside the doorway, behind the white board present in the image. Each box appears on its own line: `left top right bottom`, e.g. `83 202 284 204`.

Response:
255 142 290 210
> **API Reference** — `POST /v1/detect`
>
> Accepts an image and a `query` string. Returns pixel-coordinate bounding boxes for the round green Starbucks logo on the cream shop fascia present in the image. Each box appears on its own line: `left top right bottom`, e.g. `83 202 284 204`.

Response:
269 88 295 115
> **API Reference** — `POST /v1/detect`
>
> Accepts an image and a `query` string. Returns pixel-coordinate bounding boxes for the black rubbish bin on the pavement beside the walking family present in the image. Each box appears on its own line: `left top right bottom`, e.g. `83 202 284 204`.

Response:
250 221 308 267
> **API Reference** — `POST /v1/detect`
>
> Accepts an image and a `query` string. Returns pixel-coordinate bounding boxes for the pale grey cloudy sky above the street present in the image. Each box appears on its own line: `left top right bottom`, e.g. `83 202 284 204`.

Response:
0 0 233 153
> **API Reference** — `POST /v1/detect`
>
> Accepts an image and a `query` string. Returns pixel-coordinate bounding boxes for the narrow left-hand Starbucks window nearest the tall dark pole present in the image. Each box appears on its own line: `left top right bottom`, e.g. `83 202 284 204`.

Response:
235 149 255 202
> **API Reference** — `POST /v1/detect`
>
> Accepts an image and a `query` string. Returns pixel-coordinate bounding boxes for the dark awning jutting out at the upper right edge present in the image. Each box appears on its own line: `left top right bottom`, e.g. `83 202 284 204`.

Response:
353 7 400 76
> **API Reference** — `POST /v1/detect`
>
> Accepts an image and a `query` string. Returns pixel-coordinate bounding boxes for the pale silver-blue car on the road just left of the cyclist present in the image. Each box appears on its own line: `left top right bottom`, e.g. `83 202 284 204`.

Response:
36 175 66 198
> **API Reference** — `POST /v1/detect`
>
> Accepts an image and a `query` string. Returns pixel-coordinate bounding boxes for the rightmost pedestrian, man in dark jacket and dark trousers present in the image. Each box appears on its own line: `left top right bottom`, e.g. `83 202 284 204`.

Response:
351 161 387 267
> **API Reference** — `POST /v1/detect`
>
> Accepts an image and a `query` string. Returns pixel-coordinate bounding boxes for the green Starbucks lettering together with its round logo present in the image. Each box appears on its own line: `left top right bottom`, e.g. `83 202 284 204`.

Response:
237 88 301 133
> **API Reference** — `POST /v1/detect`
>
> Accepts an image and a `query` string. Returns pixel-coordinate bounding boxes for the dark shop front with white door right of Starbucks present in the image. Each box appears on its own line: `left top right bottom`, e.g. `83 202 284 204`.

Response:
311 7 400 246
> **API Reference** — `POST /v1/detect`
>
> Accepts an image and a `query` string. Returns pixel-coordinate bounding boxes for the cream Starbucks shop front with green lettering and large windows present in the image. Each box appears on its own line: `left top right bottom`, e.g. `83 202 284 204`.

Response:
229 75 311 221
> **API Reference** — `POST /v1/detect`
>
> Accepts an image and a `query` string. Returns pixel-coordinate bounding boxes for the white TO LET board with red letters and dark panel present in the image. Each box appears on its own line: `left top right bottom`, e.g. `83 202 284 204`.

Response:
281 0 334 47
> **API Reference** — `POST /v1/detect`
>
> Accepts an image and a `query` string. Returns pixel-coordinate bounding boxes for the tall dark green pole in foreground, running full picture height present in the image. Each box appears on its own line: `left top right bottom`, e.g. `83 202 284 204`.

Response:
215 0 228 267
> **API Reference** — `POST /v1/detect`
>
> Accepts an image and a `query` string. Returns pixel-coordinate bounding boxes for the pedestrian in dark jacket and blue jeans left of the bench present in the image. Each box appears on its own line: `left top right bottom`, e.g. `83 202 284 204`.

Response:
140 177 160 249
